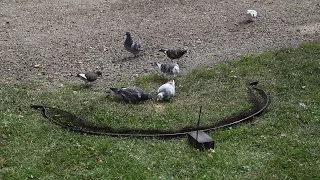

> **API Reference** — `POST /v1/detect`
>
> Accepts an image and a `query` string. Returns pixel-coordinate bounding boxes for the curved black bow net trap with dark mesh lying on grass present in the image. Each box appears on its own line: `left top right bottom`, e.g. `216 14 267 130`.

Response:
31 85 269 137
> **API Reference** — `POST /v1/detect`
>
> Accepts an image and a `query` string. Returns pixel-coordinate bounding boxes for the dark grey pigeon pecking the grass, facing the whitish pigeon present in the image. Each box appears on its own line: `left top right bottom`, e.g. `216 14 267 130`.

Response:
107 87 153 103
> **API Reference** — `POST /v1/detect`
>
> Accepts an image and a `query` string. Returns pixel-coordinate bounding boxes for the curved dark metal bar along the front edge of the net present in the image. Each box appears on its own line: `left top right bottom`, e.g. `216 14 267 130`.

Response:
31 86 270 137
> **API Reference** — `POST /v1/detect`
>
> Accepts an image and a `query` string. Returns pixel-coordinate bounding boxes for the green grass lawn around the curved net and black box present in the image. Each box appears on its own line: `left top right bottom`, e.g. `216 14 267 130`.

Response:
0 41 320 179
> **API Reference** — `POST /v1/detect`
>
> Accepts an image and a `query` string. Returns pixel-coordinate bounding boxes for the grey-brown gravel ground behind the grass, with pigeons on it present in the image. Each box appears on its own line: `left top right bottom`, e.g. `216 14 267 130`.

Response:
0 0 320 87
